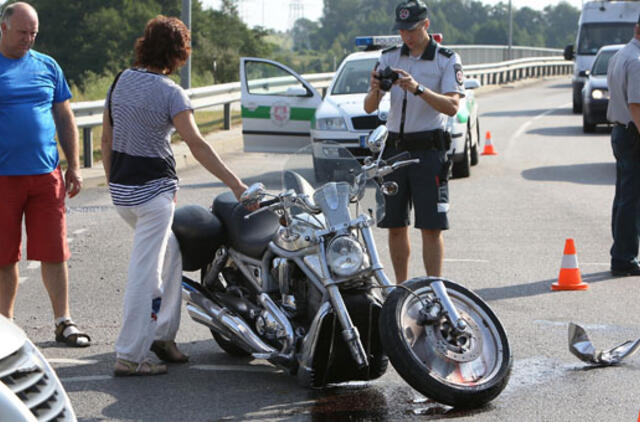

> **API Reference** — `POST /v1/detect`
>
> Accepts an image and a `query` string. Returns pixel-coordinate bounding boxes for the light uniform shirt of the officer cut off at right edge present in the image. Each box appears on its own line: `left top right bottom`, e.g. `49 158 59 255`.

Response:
607 38 640 126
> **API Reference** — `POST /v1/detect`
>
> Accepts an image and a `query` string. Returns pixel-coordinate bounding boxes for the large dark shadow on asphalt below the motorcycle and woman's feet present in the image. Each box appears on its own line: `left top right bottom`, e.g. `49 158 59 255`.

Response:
56 340 495 422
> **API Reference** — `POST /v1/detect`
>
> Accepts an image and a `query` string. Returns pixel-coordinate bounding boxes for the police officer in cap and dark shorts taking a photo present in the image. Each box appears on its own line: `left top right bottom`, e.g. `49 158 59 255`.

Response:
364 0 464 283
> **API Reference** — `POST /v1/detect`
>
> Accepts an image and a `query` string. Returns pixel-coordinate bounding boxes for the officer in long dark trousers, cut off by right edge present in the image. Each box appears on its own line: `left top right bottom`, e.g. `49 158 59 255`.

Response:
607 17 640 276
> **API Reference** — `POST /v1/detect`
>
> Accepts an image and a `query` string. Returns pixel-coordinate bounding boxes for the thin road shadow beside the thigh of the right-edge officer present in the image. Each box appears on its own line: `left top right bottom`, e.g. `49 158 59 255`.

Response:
520 163 616 185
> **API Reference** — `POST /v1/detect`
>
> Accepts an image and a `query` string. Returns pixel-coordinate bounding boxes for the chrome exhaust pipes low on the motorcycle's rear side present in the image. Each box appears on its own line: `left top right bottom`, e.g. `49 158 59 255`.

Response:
182 283 278 356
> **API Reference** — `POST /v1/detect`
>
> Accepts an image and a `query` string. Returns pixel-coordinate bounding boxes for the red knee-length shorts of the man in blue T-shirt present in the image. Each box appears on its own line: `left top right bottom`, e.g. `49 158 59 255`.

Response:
0 167 71 267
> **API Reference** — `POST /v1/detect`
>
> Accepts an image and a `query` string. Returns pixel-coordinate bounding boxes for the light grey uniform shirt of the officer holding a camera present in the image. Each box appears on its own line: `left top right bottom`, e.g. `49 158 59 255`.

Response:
377 38 465 133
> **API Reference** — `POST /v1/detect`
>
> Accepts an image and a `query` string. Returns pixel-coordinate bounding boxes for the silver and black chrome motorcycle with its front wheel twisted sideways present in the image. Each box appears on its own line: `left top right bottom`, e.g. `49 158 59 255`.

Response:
173 126 512 408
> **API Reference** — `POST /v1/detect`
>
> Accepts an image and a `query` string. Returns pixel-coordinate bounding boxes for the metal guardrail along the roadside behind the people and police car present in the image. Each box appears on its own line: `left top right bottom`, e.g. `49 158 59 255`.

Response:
71 56 573 167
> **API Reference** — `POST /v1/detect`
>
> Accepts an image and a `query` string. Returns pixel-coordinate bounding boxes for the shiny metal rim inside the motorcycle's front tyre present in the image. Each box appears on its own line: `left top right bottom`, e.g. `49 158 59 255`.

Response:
399 287 504 388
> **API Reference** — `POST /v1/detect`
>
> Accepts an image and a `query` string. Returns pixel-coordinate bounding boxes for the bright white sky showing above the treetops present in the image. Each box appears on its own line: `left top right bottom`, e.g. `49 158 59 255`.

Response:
200 0 583 31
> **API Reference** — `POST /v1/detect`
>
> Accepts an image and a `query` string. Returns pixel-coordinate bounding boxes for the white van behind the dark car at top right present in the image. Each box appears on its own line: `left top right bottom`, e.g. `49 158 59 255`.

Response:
564 1 640 113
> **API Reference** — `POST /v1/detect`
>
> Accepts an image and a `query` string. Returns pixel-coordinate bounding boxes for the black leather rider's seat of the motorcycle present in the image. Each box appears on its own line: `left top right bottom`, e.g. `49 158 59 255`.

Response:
213 192 279 259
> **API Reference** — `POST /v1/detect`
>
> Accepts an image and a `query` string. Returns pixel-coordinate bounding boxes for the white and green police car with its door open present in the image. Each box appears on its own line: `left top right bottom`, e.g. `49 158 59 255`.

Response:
240 34 482 179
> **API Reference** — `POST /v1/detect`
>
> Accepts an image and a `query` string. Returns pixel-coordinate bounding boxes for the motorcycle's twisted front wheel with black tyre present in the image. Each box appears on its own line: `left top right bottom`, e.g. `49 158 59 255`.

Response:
380 277 512 408
